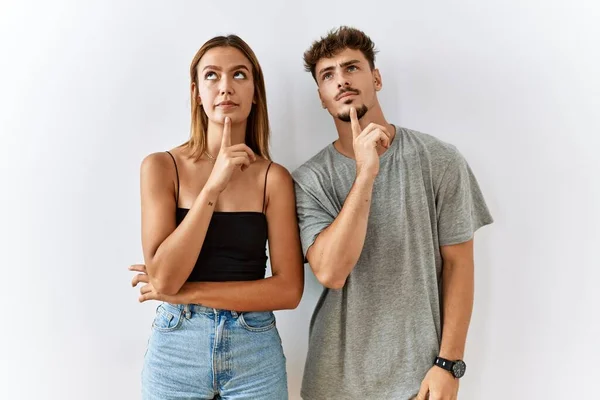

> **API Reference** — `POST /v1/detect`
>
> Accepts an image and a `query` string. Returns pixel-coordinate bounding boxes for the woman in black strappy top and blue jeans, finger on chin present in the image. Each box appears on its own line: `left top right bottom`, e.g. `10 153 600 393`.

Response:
130 35 304 400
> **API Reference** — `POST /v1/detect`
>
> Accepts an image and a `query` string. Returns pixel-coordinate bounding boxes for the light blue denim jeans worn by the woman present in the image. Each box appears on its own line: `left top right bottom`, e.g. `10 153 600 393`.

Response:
142 303 288 400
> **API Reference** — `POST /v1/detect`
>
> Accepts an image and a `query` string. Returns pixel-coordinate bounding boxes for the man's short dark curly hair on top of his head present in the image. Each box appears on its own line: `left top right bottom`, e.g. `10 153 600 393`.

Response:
304 26 377 81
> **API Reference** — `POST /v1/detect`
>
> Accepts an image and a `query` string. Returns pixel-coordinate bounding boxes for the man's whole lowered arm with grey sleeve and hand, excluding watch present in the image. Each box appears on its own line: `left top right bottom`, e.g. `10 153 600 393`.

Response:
417 143 493 400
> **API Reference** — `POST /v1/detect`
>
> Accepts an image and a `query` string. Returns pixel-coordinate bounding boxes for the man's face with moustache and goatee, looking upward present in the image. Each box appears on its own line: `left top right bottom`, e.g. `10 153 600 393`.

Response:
315 49 381 122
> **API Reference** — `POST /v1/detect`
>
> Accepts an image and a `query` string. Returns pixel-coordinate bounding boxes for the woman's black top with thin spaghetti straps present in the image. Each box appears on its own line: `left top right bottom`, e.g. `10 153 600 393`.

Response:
167 152 272 282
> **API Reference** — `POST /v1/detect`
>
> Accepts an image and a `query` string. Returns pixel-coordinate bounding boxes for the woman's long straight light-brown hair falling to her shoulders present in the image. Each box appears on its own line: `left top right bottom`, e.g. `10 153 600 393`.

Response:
181 35 271 160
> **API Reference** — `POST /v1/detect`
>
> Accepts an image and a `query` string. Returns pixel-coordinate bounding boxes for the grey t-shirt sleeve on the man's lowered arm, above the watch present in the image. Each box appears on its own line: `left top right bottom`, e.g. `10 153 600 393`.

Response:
436 151 493 246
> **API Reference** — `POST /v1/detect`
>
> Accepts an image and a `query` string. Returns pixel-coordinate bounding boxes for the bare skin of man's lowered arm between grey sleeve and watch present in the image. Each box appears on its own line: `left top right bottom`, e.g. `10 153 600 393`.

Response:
440 240 474 360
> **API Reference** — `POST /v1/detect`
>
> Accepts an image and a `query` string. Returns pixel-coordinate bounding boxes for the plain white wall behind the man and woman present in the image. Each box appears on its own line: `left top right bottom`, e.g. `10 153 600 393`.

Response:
0 0 600 400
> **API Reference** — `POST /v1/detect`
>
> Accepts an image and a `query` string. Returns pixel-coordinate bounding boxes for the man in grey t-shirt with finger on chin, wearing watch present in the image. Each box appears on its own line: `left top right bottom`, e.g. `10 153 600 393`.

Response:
293 27 492 400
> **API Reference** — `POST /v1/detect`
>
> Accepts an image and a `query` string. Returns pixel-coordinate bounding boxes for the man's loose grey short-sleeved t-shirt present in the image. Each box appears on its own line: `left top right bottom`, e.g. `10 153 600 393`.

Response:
293 128 492 400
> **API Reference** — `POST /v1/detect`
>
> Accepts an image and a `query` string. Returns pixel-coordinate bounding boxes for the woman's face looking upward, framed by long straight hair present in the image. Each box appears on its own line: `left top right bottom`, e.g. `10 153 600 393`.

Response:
197 47 254 124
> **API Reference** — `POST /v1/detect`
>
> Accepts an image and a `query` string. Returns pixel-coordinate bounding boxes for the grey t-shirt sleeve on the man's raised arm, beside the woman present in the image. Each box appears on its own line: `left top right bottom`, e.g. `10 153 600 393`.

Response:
294 181 335 262
